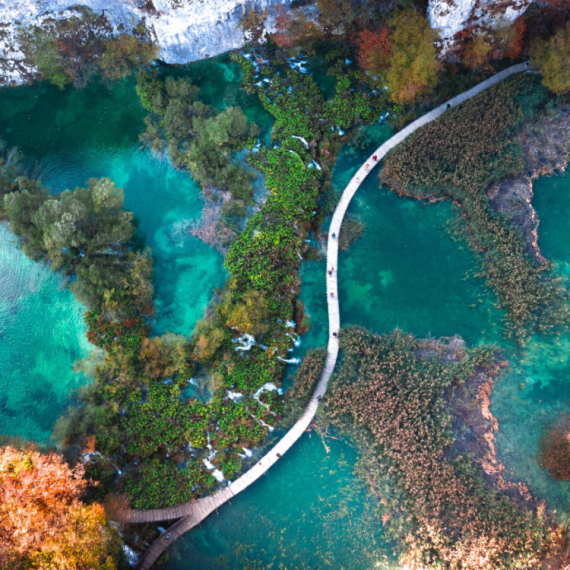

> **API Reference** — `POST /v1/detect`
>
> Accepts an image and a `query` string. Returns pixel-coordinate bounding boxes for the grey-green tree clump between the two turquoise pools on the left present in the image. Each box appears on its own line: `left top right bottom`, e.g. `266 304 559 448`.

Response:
4 178 141 307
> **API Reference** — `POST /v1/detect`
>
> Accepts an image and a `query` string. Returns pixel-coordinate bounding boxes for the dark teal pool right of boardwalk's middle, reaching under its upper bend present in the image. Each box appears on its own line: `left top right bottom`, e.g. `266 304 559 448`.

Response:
334 131 500 344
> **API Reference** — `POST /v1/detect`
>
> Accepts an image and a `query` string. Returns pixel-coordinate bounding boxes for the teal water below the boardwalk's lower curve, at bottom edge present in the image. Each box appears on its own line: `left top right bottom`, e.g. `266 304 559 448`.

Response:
160 431 391 570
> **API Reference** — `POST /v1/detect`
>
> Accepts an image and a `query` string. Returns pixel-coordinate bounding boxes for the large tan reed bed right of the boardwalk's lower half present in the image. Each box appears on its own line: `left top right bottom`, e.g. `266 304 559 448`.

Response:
325 328 551 570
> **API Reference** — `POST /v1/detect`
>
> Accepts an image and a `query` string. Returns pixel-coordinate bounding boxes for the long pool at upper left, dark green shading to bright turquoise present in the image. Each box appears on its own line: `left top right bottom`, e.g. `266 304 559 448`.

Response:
0 73 226 335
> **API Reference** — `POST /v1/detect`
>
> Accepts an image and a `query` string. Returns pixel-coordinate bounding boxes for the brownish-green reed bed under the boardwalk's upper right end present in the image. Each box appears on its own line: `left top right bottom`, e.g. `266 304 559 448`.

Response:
380 76 568 342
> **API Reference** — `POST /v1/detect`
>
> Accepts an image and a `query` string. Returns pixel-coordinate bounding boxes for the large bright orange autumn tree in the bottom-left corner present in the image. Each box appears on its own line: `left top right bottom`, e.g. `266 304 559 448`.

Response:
0 446 120 570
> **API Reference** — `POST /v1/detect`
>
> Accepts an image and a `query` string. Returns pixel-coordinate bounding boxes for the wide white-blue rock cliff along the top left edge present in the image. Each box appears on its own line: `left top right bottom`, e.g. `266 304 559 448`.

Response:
0 0 291 85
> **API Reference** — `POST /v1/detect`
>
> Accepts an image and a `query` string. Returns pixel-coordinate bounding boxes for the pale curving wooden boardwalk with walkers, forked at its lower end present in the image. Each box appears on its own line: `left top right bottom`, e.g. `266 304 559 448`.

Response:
121 63 528 570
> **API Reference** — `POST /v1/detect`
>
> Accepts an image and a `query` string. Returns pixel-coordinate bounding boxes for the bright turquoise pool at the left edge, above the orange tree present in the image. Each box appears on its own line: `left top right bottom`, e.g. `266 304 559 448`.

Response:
0 223 90 442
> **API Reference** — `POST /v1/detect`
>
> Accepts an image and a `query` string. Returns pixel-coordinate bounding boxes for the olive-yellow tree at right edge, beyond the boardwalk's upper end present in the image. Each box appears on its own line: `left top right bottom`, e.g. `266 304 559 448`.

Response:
530 22 570 95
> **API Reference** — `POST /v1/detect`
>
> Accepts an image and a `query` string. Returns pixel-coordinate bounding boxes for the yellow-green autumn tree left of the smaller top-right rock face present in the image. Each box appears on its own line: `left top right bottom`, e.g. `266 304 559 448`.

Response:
385 9 440 104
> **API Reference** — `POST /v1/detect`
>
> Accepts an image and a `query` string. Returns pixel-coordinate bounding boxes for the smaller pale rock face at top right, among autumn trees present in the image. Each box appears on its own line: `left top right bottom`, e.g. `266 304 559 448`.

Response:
427 0 531 51
